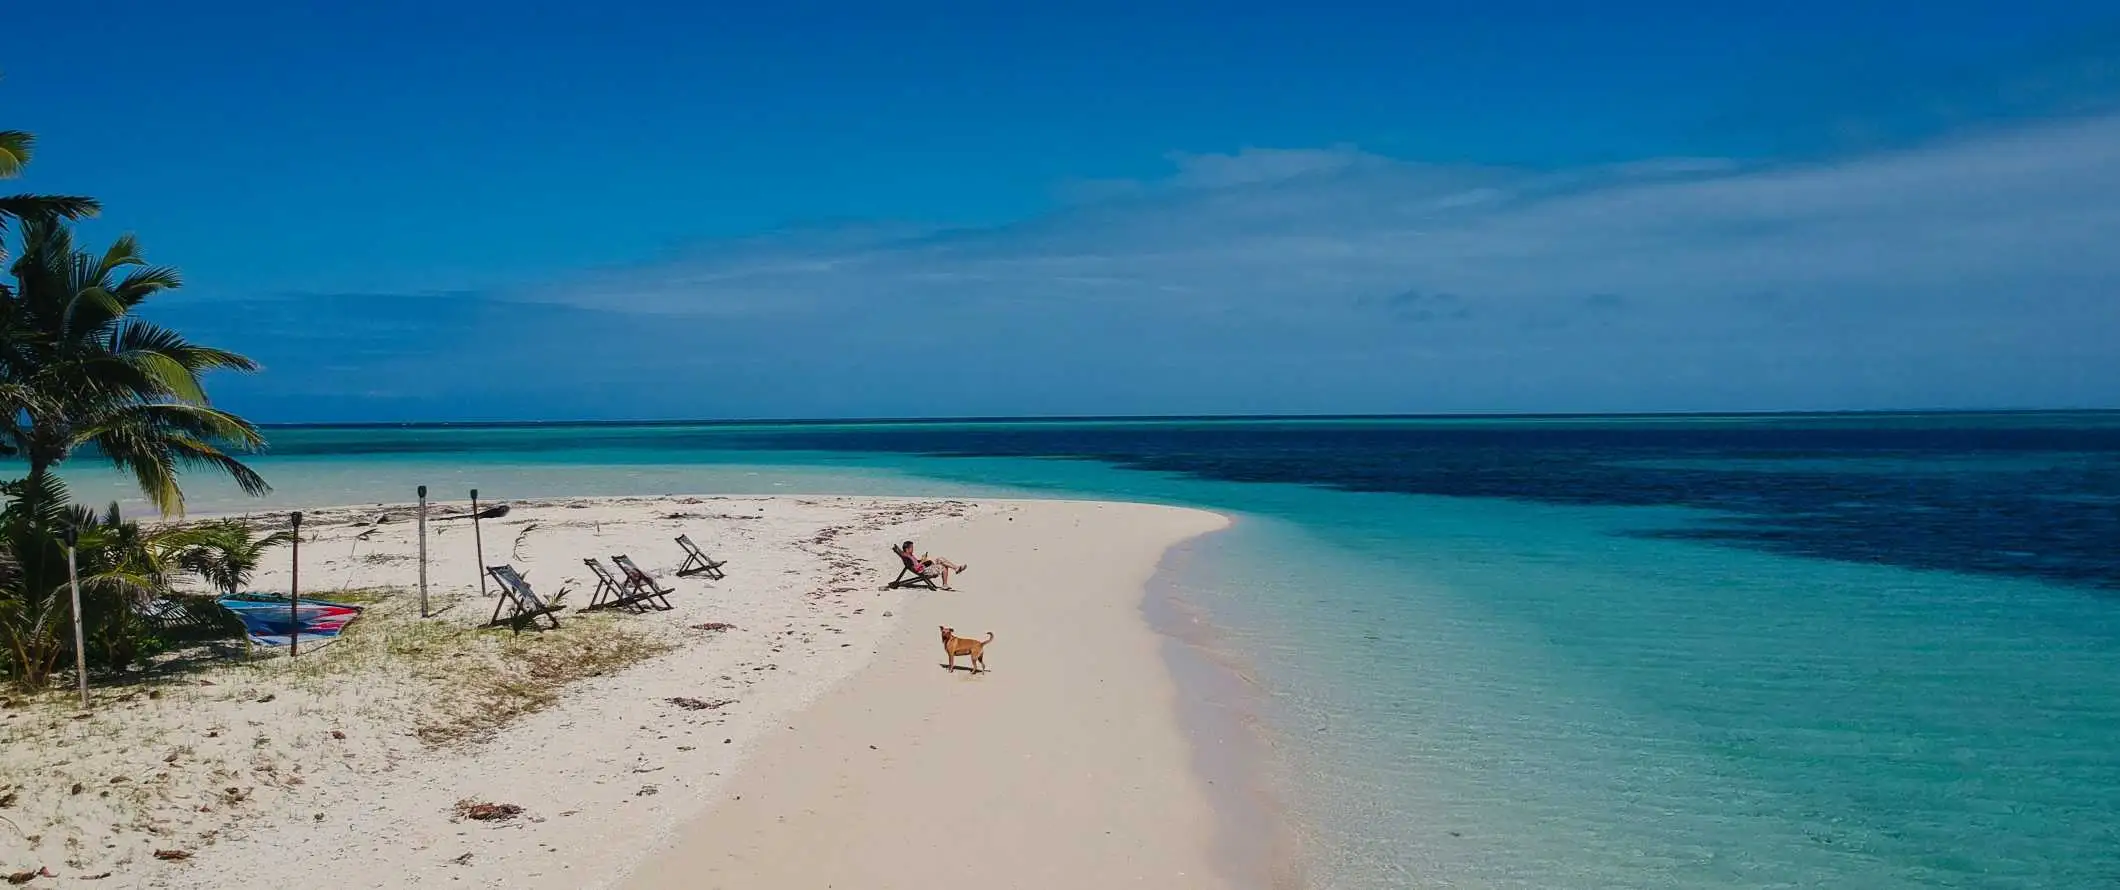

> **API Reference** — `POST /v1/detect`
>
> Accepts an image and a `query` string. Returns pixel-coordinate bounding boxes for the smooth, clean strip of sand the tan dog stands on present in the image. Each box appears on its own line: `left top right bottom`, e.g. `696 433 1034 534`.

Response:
623 502 1225 890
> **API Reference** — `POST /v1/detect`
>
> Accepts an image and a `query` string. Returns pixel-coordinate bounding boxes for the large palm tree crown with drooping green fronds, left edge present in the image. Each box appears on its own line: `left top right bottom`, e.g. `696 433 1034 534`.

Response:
0 216 269 517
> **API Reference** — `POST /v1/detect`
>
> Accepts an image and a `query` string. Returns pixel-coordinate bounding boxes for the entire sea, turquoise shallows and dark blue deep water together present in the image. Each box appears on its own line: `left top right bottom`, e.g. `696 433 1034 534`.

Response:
68 413 2120 888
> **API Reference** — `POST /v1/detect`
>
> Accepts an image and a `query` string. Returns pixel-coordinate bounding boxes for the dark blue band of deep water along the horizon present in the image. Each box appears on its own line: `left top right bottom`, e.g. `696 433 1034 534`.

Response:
243 413 2120 591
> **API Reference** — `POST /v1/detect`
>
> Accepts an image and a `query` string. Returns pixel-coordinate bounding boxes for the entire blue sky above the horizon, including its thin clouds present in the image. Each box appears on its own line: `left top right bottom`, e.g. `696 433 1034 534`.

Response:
0 2 2120 422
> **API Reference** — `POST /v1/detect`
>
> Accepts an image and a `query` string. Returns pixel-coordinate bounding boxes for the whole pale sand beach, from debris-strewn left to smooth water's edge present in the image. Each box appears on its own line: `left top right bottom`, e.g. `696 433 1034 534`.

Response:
0 496 1225 888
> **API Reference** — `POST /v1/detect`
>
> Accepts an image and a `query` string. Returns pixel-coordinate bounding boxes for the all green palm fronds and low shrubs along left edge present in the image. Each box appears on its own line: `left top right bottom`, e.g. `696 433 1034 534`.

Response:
0 116 273 689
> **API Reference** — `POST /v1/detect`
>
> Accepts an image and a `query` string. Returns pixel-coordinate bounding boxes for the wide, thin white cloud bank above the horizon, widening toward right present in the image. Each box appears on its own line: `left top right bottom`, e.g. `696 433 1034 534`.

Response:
199 117 2120 415
